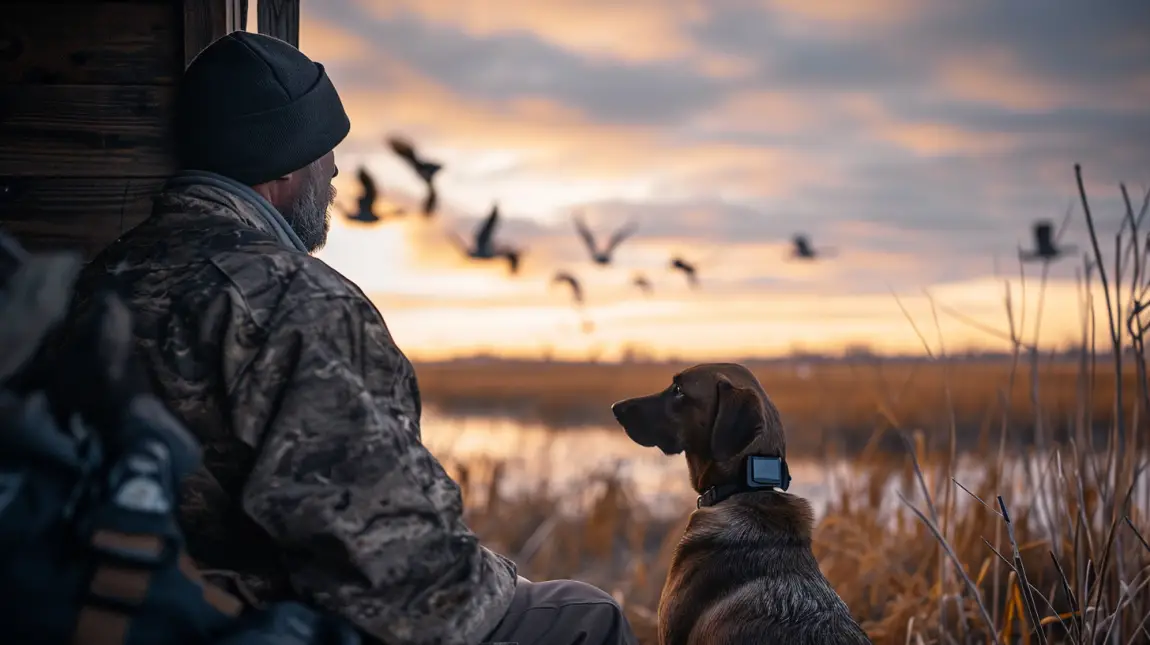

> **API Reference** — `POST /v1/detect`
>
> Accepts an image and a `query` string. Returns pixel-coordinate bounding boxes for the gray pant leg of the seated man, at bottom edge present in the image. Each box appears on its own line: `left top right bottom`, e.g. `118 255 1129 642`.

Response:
483 578 638 645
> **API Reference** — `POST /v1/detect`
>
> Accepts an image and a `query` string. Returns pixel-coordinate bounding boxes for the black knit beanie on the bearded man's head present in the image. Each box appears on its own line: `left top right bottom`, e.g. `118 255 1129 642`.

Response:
175 31 351 186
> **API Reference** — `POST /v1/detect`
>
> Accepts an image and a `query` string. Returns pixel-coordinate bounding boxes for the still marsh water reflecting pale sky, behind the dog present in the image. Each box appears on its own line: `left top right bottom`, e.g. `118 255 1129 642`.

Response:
422 407 1150 528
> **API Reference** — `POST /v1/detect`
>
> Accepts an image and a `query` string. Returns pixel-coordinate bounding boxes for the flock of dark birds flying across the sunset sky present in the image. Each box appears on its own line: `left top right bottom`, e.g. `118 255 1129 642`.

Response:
339 136 1075 331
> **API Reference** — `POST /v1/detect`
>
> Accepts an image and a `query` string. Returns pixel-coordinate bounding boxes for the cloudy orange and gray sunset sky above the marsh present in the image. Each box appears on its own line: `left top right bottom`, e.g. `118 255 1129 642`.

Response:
273 0 1150 360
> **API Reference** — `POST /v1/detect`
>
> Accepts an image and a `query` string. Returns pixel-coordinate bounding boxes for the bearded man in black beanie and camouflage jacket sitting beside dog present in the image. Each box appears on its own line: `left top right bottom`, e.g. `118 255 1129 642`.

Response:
67 32 634 645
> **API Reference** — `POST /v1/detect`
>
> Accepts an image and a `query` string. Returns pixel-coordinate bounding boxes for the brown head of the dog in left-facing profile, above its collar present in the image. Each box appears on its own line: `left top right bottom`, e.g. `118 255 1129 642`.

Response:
611 363 787 486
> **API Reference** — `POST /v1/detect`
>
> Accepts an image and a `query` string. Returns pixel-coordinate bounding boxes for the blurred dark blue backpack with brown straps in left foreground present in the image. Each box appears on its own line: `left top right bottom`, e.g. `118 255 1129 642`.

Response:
0 233 360 645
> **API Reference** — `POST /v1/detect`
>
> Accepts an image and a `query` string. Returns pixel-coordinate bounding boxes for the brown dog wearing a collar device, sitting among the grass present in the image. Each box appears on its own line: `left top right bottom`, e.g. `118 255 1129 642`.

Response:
611 363 871 645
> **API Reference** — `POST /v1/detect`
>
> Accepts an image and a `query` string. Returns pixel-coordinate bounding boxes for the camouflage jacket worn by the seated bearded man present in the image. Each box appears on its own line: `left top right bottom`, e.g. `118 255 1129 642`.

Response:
76 172 516 644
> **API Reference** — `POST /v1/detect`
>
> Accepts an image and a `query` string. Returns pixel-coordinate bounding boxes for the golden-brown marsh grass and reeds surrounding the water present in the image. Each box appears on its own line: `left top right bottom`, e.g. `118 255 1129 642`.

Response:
417 359 1150 645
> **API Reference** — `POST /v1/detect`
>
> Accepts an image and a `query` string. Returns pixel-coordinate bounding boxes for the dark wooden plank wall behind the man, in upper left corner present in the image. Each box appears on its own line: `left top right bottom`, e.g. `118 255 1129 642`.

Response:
0 0 183 258
